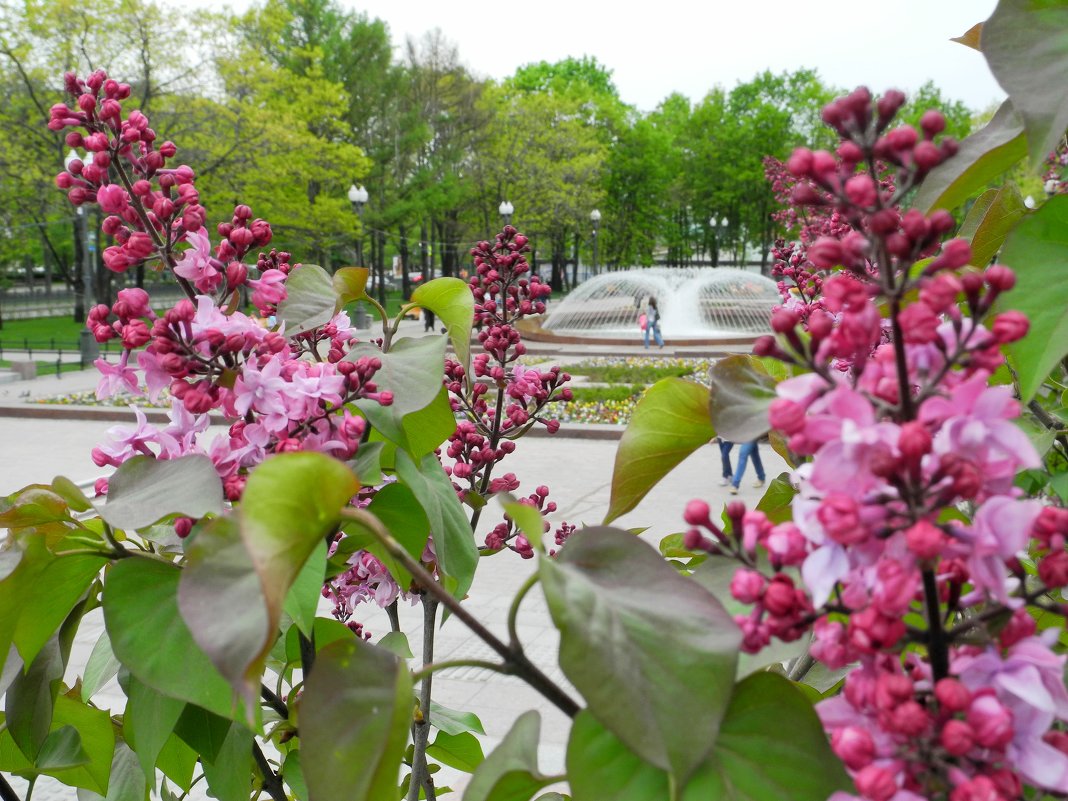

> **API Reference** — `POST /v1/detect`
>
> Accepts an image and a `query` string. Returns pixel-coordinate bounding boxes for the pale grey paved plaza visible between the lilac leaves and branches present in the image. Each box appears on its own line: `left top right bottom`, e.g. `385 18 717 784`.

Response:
0 324 785 801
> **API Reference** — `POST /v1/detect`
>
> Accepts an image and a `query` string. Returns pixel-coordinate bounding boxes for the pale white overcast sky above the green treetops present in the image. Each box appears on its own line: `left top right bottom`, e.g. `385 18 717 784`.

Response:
337 0 1004 111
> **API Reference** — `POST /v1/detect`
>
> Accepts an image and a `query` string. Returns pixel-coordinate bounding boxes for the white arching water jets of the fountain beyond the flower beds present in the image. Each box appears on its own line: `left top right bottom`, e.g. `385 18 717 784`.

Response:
529 267 782 344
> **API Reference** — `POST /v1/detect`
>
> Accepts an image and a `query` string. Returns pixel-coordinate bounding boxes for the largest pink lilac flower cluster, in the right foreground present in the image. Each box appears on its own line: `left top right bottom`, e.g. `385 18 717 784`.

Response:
686 84 1068 801
